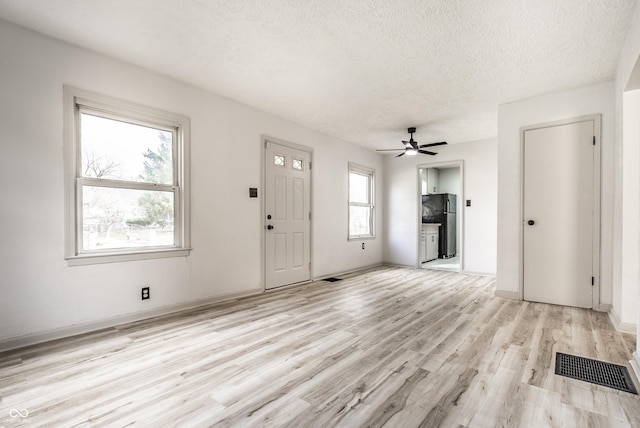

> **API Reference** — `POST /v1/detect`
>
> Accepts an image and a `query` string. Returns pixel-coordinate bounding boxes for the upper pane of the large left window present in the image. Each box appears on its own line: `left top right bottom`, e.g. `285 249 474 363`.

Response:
80 113 173 184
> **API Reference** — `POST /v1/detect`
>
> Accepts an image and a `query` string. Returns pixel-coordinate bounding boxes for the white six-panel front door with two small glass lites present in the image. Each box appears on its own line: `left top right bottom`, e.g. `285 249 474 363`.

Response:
264 141 311 289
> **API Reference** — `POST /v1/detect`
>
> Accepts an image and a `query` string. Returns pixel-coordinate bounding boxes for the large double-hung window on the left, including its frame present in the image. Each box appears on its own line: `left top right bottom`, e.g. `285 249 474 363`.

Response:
64 87 189 265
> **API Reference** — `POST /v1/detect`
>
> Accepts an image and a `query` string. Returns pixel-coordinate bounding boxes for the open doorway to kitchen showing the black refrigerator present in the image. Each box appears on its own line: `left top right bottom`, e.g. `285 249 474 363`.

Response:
417 161 464 272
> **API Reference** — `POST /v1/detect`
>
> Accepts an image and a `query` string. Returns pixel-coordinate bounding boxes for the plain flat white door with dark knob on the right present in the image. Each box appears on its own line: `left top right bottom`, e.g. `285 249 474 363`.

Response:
523 120 595 308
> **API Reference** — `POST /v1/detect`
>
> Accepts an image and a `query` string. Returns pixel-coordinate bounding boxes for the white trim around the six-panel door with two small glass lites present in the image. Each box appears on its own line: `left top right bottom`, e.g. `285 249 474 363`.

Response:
259 135 315 291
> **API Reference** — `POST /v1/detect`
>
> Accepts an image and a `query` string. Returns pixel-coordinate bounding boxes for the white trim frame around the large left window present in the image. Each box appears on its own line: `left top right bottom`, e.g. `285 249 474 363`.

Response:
63 85 191 266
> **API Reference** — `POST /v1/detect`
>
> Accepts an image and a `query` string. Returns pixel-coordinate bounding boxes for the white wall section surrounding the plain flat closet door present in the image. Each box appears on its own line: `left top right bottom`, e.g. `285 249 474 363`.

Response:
496 82 614 305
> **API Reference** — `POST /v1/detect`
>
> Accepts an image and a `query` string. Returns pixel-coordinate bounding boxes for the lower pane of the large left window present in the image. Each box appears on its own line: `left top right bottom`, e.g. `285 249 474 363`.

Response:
82 186 174 251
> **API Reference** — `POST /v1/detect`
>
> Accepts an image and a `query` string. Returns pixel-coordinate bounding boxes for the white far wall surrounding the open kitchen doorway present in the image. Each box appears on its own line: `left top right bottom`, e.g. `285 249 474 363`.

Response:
384 139 497 274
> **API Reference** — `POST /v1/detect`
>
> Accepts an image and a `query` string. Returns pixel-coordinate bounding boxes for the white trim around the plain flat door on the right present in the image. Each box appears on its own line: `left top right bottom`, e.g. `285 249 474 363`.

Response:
518 114 608 311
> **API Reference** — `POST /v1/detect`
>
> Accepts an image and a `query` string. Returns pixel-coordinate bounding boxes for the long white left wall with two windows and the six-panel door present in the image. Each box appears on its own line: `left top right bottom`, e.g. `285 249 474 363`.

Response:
0 21 384 348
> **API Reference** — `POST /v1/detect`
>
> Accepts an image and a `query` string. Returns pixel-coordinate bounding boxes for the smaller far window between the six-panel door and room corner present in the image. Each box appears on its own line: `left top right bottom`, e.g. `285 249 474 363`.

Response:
349 163 375 239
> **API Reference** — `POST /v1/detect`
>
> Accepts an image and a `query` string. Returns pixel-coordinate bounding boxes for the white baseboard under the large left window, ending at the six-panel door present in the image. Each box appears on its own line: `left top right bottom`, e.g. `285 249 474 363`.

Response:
0 288 264 352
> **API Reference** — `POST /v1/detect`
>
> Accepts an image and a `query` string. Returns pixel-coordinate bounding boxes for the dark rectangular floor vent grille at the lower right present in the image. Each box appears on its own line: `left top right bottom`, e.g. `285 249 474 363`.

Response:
556 352 638 395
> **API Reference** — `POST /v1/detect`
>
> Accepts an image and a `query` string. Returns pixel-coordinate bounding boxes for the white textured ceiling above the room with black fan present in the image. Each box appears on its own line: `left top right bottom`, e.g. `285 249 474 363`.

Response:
0 0 636 149
